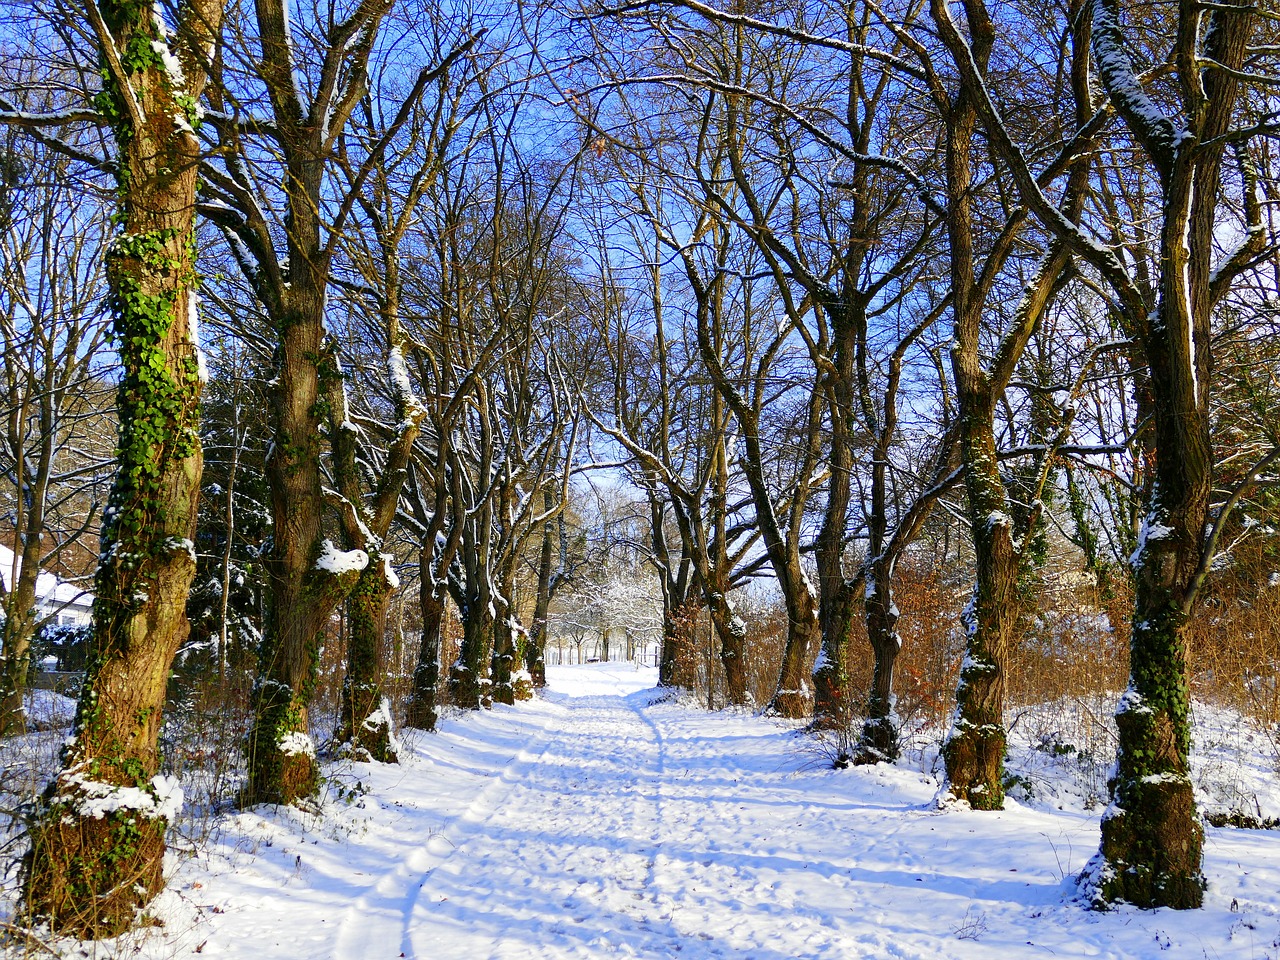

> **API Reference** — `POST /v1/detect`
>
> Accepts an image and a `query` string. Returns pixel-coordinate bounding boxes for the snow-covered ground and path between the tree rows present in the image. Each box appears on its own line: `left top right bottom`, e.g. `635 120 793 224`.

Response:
2 664 1280 960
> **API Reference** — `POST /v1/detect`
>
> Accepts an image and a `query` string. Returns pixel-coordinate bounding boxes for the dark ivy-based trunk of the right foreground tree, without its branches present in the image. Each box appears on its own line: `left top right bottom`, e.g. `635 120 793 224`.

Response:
1092 239 1212 909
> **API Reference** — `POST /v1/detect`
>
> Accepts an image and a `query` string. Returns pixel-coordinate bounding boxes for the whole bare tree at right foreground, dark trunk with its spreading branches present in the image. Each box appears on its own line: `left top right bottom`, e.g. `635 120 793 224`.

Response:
936 0 1280 908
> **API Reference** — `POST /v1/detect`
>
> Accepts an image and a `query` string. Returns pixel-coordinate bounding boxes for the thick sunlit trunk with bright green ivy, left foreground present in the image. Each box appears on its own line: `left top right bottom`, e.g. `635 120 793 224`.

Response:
23 1 221 937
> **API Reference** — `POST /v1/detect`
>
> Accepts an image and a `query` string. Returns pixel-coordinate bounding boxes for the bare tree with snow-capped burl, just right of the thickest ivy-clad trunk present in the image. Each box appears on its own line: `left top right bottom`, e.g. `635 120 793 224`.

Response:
201 0 463 803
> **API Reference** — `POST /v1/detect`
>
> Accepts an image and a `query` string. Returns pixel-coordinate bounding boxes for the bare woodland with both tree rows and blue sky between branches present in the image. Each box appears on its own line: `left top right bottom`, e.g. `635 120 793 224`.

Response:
0 0 1280 936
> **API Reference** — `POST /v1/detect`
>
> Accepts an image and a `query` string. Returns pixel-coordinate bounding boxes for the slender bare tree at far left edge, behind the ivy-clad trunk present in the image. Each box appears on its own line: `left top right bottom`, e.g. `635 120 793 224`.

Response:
0 136 109 736
